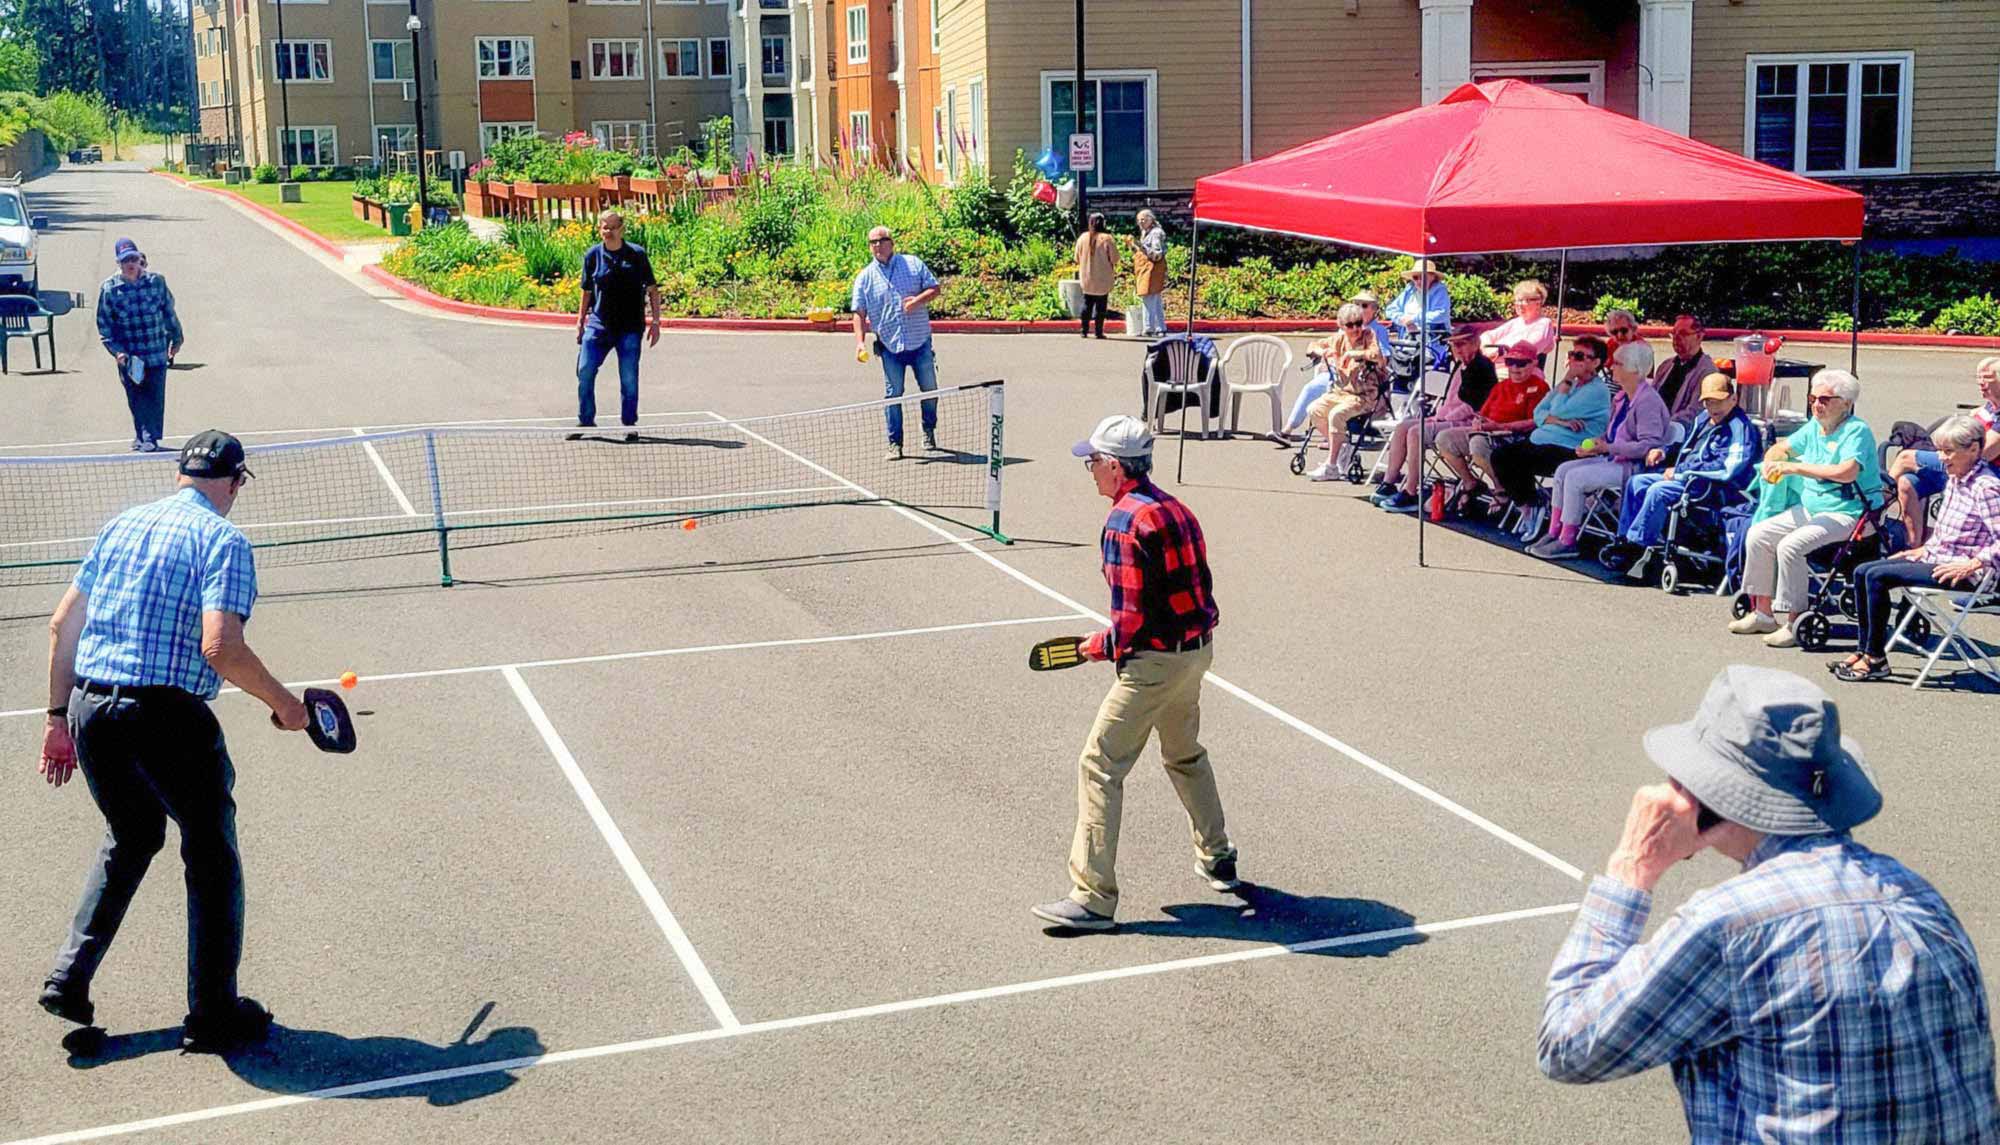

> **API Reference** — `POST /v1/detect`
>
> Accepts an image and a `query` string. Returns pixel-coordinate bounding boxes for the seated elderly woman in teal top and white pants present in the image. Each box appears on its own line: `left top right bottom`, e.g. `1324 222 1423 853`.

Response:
1730 370 1882 649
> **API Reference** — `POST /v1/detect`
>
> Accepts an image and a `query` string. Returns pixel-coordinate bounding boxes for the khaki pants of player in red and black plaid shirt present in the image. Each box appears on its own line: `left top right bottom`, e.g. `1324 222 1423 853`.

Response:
1070 645 1236 915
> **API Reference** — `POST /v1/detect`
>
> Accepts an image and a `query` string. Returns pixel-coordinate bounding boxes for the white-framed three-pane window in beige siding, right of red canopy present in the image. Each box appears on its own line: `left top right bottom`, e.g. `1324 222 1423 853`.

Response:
1744 52 1912 174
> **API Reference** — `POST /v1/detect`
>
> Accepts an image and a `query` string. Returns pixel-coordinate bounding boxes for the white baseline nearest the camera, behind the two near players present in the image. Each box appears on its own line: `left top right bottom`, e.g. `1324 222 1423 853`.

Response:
4 903 1578 1145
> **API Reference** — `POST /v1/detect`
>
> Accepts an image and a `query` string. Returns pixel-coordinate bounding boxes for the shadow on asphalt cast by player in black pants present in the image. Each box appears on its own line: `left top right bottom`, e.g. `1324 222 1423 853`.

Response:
64 1003 546 1105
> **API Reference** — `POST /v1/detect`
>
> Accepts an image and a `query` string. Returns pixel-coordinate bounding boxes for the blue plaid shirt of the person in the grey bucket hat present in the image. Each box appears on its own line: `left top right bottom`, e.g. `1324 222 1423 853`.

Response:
1540 835 2000 1145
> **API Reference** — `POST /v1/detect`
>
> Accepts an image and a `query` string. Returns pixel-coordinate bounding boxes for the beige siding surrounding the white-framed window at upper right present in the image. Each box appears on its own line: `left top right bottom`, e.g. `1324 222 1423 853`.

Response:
1690 0 2000 174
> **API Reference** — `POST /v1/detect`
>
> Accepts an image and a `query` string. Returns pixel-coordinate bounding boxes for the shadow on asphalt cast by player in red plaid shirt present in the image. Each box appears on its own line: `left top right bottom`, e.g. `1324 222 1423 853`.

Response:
1118 883 1424 959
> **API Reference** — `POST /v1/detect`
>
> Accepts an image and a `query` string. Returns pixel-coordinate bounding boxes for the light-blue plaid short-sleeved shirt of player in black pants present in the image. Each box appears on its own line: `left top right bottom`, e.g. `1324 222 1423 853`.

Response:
74 488 256 699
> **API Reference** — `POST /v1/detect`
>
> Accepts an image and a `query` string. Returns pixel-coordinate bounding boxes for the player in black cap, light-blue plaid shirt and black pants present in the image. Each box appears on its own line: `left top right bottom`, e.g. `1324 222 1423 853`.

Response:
40 430 306 1051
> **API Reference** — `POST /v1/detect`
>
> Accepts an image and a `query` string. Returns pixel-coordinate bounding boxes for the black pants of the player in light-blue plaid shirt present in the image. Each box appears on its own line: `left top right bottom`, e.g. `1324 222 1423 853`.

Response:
48 687 244 1015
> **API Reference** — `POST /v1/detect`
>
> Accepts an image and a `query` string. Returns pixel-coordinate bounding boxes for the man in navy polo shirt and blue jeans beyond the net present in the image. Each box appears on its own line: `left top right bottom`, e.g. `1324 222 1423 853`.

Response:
576 210 660 436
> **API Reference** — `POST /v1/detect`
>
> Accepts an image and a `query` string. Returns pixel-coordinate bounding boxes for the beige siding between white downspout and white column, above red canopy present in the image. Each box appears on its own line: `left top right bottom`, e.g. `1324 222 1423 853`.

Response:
1248 0 1422 161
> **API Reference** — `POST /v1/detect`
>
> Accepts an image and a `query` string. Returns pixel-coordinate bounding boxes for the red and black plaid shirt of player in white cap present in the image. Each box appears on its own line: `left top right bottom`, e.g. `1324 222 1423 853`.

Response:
1084 478 1216 661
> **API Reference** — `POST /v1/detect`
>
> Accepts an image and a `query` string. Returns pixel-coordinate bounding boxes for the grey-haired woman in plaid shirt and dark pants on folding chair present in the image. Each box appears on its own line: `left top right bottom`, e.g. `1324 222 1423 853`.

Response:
1828 416 2000 683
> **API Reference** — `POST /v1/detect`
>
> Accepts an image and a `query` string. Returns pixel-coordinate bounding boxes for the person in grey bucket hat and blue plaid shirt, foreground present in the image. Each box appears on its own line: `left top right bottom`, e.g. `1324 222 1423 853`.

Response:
1540 665 2000 1145
